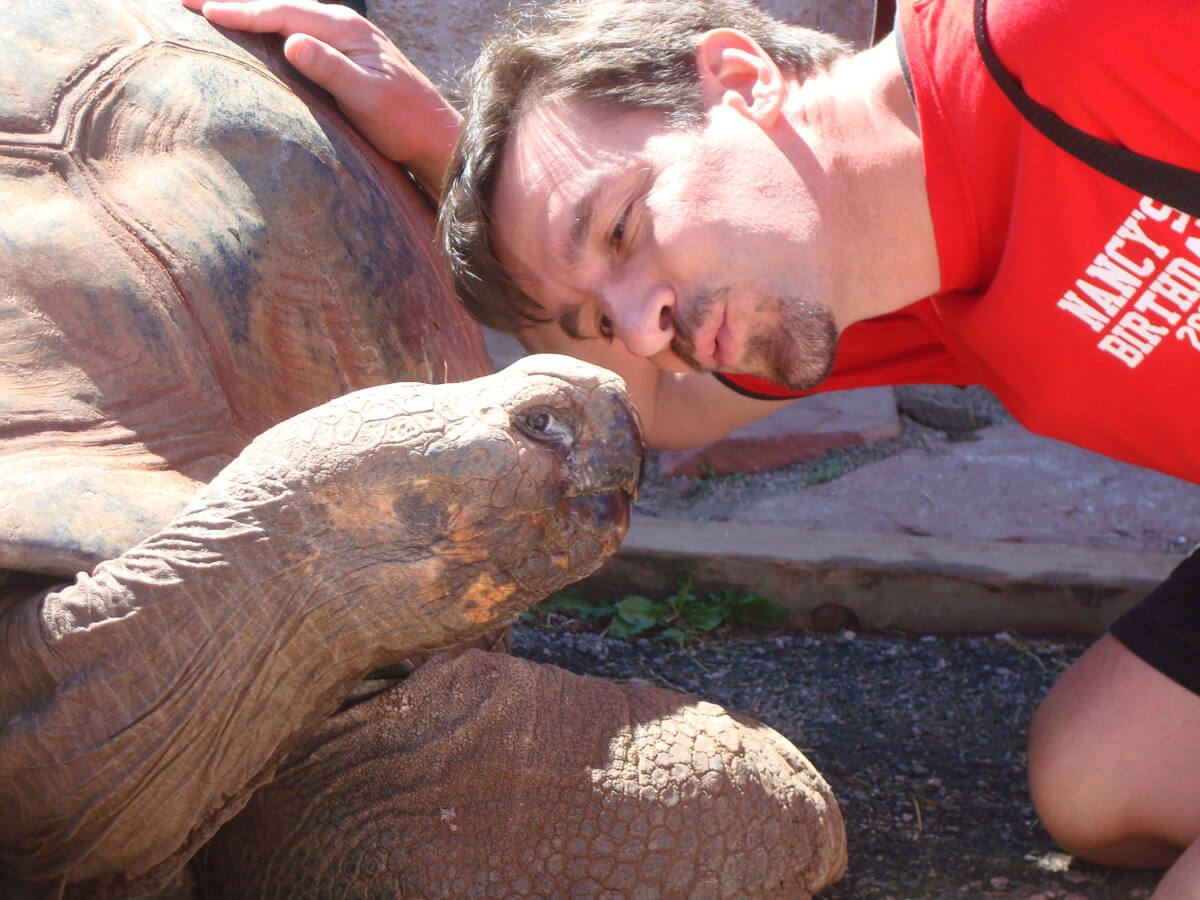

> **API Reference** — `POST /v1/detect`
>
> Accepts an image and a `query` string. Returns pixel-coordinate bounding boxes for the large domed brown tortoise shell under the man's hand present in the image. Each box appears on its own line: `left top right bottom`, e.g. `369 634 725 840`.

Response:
0 0 491 575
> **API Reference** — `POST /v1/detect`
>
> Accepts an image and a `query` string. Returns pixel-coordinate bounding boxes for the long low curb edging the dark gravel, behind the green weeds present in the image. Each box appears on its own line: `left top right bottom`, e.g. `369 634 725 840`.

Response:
582 515 1183 636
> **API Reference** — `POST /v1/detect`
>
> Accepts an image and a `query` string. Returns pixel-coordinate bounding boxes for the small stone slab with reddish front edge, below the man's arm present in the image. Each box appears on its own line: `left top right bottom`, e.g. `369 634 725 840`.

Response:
658 388 900 478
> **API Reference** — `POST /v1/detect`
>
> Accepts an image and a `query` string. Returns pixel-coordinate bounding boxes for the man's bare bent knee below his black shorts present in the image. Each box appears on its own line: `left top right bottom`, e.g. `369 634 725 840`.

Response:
1030 633 1200 873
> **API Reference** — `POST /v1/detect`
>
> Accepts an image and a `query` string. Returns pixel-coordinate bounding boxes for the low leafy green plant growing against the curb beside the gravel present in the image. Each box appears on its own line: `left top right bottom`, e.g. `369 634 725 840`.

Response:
527 575 788 644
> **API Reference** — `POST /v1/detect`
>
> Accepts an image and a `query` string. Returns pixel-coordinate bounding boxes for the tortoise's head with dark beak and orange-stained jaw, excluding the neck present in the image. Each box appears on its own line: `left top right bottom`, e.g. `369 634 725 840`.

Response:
430 355 644 595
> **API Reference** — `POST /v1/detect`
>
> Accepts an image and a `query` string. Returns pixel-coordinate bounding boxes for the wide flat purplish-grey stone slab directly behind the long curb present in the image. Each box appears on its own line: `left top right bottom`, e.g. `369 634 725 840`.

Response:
732 425 1200 552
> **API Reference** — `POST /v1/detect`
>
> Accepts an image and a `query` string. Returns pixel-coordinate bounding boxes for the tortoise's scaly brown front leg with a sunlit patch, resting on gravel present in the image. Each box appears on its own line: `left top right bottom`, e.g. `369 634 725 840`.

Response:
197 650 846 900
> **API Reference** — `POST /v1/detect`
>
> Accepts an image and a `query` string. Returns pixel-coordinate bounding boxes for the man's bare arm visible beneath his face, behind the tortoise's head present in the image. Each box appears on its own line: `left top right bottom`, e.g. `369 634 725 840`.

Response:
517 323 788 450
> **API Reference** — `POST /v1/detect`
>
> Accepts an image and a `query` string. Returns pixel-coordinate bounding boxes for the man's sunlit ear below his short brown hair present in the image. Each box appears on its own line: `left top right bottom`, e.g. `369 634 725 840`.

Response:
696 28 786 127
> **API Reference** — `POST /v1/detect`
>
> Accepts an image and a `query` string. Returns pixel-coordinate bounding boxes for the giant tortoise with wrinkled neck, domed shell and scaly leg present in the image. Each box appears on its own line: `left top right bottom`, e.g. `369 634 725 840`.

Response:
0 0 845 896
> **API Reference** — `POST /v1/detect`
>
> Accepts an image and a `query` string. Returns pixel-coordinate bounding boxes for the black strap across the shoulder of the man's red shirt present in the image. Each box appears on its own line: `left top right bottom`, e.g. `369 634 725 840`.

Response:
974 0 1200 217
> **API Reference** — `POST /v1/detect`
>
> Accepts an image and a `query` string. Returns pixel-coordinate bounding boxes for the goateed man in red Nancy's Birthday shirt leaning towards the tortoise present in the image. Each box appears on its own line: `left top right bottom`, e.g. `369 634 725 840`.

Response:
188 0 1200 900
